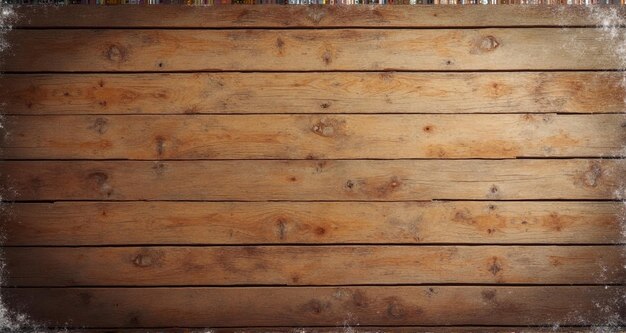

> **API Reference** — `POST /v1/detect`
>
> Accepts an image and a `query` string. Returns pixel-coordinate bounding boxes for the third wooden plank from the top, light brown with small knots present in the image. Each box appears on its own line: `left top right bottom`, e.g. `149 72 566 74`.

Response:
0 72 626 114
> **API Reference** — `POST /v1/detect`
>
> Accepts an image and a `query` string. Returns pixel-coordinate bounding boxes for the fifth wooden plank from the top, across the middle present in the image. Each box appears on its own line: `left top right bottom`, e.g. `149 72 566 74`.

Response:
0 159 626 201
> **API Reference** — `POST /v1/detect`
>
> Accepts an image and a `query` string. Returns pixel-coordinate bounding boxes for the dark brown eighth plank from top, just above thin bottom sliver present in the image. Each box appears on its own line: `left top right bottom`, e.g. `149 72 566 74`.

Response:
1 286 626 327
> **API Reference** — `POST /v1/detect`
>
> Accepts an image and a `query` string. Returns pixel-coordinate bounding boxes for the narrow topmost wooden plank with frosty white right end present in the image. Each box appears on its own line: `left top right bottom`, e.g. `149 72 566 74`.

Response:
15 5 625 28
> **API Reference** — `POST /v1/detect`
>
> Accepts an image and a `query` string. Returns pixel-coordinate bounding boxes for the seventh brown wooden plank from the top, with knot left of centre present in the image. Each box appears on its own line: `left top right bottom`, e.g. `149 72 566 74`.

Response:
2 245 626 287
